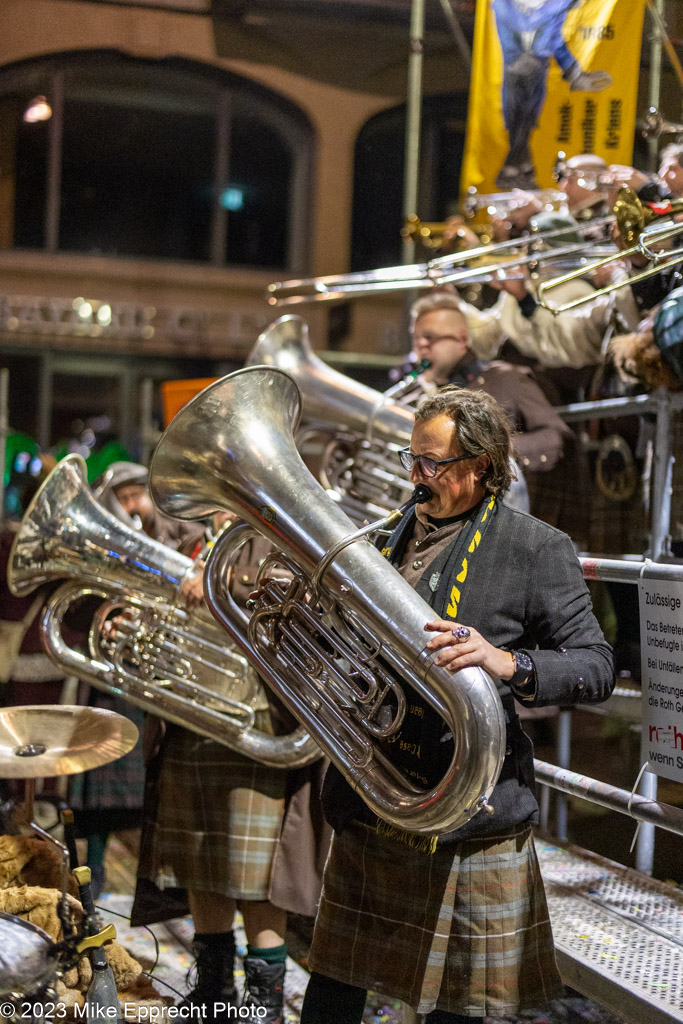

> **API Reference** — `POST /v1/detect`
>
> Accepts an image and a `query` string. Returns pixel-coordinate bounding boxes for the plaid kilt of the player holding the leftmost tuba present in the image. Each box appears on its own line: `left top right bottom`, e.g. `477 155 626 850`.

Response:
143 711 288 900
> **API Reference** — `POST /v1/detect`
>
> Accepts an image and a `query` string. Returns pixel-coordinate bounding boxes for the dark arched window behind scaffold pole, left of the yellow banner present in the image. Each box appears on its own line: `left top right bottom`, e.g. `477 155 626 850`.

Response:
351 92 467 270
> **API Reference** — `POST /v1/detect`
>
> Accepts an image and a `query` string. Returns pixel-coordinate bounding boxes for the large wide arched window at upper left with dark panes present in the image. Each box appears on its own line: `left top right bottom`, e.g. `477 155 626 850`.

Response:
0 51 313 272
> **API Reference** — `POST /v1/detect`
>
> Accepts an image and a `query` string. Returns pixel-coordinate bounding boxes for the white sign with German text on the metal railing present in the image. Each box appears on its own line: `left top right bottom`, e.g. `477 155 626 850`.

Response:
638 579 683 782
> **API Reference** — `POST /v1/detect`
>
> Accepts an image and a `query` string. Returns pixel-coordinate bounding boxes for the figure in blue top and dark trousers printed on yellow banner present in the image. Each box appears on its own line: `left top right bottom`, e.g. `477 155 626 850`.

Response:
493 0 612 189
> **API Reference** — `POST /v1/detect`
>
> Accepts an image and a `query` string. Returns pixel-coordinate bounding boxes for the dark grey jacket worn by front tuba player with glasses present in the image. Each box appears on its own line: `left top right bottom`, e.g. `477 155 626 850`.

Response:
323 501 614 842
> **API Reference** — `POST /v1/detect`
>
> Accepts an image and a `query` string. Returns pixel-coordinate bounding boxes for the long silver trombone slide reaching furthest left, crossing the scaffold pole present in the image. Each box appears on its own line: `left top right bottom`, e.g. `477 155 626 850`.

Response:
266 216 616 307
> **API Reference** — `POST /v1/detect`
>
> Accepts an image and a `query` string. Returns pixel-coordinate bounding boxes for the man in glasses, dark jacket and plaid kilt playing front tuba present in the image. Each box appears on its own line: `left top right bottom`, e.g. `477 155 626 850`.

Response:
301 387 614 1024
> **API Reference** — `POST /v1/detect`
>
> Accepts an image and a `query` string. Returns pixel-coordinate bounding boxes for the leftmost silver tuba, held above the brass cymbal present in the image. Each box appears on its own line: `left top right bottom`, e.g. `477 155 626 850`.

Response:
7 455 321 768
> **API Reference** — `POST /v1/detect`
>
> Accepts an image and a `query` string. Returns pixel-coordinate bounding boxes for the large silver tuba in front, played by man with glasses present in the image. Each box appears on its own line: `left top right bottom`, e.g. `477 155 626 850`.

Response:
150 367 505 834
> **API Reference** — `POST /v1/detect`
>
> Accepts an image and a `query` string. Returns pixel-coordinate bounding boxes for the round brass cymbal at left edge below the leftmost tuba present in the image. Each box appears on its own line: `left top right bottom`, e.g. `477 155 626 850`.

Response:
0 705 138 778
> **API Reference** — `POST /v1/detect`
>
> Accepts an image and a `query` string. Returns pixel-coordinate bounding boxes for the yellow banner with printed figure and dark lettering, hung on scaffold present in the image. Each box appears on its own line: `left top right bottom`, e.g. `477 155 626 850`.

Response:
461 0 645 193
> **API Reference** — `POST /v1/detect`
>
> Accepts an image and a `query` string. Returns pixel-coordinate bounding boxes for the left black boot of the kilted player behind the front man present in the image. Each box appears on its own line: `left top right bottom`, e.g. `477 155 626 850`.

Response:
179 932 240 1021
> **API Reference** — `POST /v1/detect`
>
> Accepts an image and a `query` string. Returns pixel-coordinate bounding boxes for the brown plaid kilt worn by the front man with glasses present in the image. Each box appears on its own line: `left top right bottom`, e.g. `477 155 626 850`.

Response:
309 821 564 1017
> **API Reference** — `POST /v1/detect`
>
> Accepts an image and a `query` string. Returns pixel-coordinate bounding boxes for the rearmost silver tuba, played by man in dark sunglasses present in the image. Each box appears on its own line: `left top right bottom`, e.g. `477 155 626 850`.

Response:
246 315 413 522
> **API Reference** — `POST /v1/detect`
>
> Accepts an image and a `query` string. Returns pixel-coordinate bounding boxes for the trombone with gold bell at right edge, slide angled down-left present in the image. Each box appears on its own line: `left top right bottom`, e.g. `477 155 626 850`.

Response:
539 185 683 314
